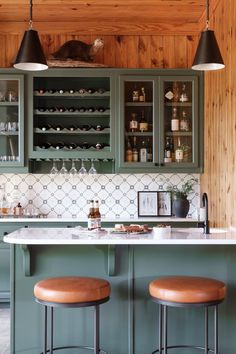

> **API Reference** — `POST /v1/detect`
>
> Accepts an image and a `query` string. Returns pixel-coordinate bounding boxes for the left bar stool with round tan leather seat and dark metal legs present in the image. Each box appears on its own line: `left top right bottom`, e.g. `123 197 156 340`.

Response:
34 276 110 354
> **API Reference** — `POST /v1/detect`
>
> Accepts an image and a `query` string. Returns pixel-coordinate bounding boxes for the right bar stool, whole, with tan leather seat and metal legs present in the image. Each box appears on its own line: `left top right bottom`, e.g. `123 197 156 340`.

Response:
149 276 226 354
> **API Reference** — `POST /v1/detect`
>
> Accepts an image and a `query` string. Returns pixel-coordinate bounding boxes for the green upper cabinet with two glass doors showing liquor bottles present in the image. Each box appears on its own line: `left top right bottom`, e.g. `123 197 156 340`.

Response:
116 70 203 173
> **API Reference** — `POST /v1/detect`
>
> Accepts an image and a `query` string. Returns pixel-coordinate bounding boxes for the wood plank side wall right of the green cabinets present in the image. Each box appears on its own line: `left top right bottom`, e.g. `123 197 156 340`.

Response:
201 0 236 227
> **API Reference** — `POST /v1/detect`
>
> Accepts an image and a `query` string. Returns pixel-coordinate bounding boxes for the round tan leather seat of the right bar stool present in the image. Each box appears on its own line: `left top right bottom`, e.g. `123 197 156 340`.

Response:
149 276 226 303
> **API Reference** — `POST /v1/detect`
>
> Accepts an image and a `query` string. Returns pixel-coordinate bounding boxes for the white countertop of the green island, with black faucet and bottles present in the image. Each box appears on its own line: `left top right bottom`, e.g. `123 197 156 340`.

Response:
4 227 236 245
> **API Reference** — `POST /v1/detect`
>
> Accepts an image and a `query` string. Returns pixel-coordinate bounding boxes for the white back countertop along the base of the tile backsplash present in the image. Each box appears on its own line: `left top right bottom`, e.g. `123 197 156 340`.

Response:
0 216 197 224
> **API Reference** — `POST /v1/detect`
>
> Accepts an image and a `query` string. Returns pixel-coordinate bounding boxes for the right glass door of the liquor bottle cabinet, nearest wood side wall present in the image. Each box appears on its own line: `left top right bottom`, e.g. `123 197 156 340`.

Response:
161 77 198 168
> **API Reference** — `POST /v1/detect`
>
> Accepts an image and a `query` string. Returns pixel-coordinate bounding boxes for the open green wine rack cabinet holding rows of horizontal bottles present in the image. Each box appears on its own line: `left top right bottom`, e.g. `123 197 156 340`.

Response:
29 69 114 159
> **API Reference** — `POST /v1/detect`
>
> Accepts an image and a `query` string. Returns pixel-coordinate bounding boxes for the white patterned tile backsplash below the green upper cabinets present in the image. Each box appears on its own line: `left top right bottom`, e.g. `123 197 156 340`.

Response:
0 173 200 220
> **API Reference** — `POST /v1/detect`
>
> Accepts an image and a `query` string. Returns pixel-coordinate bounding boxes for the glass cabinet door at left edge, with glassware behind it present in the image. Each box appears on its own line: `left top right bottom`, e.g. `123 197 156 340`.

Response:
0 75 24 167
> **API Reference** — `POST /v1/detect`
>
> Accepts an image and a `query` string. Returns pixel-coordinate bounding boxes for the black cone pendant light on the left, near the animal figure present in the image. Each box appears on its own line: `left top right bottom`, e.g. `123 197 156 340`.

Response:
14 0 48 71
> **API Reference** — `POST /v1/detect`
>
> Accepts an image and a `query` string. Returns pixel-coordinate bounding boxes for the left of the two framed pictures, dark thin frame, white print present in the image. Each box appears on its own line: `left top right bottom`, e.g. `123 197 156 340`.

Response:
138 191 158 216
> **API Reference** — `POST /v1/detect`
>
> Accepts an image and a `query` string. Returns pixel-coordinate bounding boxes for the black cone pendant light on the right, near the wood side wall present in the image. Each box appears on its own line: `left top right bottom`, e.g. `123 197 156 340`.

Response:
192 0 225 71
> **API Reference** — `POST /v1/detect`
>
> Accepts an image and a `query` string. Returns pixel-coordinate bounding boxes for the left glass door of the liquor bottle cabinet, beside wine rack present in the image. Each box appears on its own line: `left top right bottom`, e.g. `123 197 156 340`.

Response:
120 76 157 169
